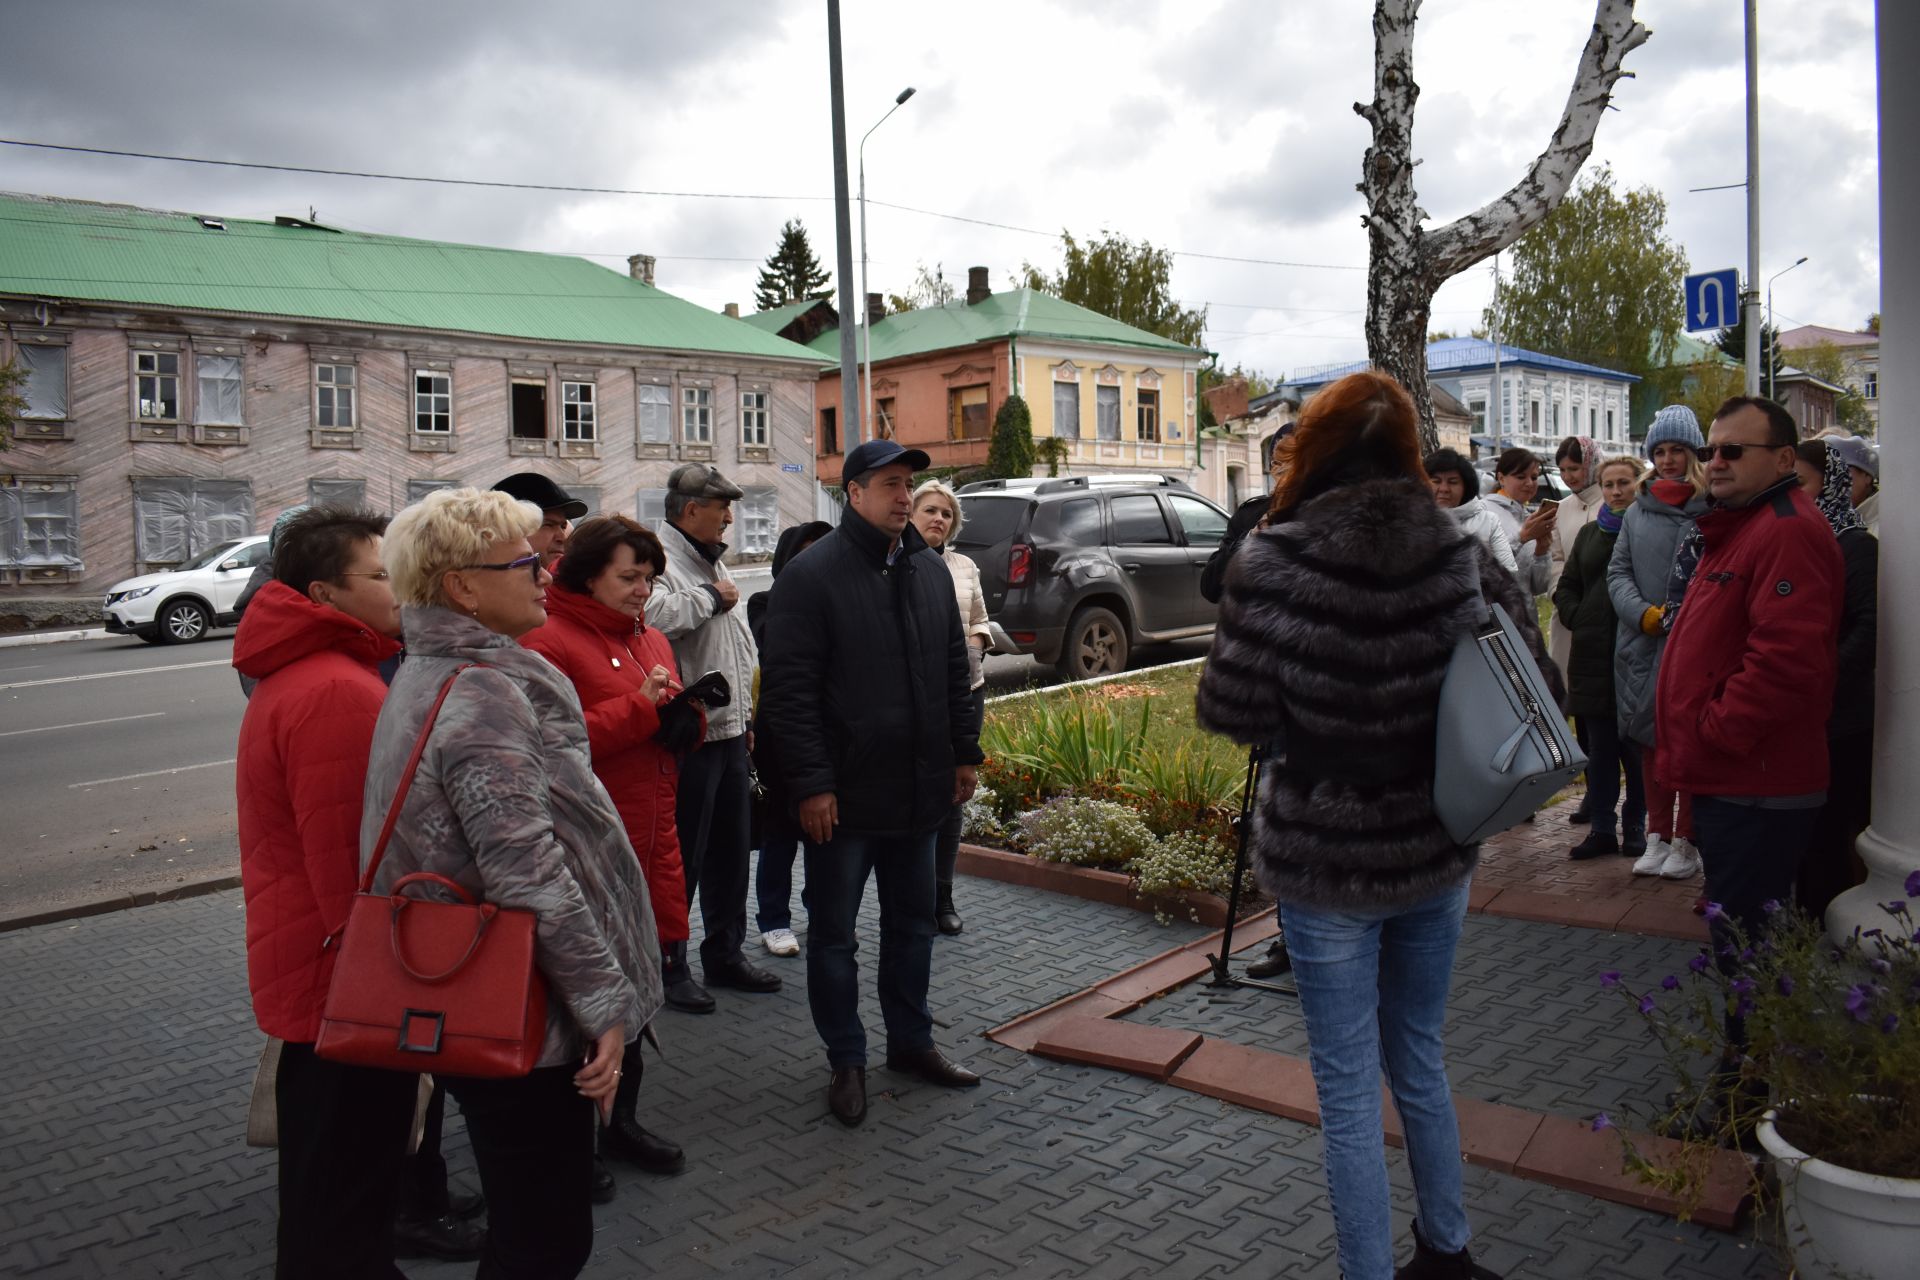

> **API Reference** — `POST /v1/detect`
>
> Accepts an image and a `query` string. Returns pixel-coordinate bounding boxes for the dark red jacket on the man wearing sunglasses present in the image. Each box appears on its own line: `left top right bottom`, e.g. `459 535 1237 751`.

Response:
1655 476 1845 796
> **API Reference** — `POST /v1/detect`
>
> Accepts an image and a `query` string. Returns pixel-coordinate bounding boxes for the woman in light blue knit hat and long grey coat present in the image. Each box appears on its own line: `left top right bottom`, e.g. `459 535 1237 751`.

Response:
1607 405 1707 881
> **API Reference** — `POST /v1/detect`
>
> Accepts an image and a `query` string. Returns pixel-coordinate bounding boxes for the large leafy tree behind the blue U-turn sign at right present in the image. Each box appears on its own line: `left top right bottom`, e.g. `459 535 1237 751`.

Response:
1484 169 1686 420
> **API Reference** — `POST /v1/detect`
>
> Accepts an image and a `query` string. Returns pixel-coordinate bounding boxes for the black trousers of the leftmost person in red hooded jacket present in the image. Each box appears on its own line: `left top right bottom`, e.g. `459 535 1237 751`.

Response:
275 1042 419 1280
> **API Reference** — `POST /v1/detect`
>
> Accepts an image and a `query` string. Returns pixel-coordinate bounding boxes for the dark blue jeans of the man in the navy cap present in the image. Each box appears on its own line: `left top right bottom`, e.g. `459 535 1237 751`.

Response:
806 831 935 1069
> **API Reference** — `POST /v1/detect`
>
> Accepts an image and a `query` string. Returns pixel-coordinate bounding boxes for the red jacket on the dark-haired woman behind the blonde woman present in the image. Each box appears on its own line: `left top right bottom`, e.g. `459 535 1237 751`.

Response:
520 583 705 944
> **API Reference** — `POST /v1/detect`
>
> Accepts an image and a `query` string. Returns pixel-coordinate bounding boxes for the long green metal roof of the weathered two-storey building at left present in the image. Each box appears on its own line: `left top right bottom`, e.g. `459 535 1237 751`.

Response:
0 194 820 367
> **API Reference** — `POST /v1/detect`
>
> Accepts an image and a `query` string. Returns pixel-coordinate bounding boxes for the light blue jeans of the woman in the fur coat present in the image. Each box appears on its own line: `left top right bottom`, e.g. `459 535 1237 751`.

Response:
1281 881 1467 1280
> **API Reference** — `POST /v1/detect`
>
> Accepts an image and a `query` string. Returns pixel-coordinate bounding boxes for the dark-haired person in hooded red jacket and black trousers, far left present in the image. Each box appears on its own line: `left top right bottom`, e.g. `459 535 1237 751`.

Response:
234 509 419 1280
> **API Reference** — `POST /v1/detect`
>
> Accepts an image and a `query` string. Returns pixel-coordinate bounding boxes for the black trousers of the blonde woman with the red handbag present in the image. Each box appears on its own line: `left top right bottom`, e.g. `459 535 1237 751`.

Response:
447 1063 593 1280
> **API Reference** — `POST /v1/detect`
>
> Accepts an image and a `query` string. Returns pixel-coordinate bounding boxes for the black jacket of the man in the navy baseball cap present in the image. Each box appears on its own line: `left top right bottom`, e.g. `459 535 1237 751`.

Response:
760 510 981 835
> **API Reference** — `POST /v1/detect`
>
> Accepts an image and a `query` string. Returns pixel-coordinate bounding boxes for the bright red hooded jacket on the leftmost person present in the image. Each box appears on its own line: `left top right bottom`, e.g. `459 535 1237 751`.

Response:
234 581 399 1042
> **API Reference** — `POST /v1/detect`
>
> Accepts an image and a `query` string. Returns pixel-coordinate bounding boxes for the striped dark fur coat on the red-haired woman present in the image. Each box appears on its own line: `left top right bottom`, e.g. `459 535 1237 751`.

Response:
1198 480 1563 912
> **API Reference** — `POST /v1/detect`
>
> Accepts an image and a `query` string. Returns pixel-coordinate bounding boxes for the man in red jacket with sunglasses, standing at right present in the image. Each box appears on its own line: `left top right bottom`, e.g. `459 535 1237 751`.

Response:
1655 395 1845 1121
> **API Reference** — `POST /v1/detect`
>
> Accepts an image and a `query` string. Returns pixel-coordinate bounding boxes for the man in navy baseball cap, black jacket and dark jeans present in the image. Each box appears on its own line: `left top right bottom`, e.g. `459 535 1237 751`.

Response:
760 439 981 1125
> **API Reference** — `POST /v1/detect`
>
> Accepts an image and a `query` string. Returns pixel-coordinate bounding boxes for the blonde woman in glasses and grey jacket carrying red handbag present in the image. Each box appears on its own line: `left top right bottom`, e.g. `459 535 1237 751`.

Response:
361 489 660 1276
